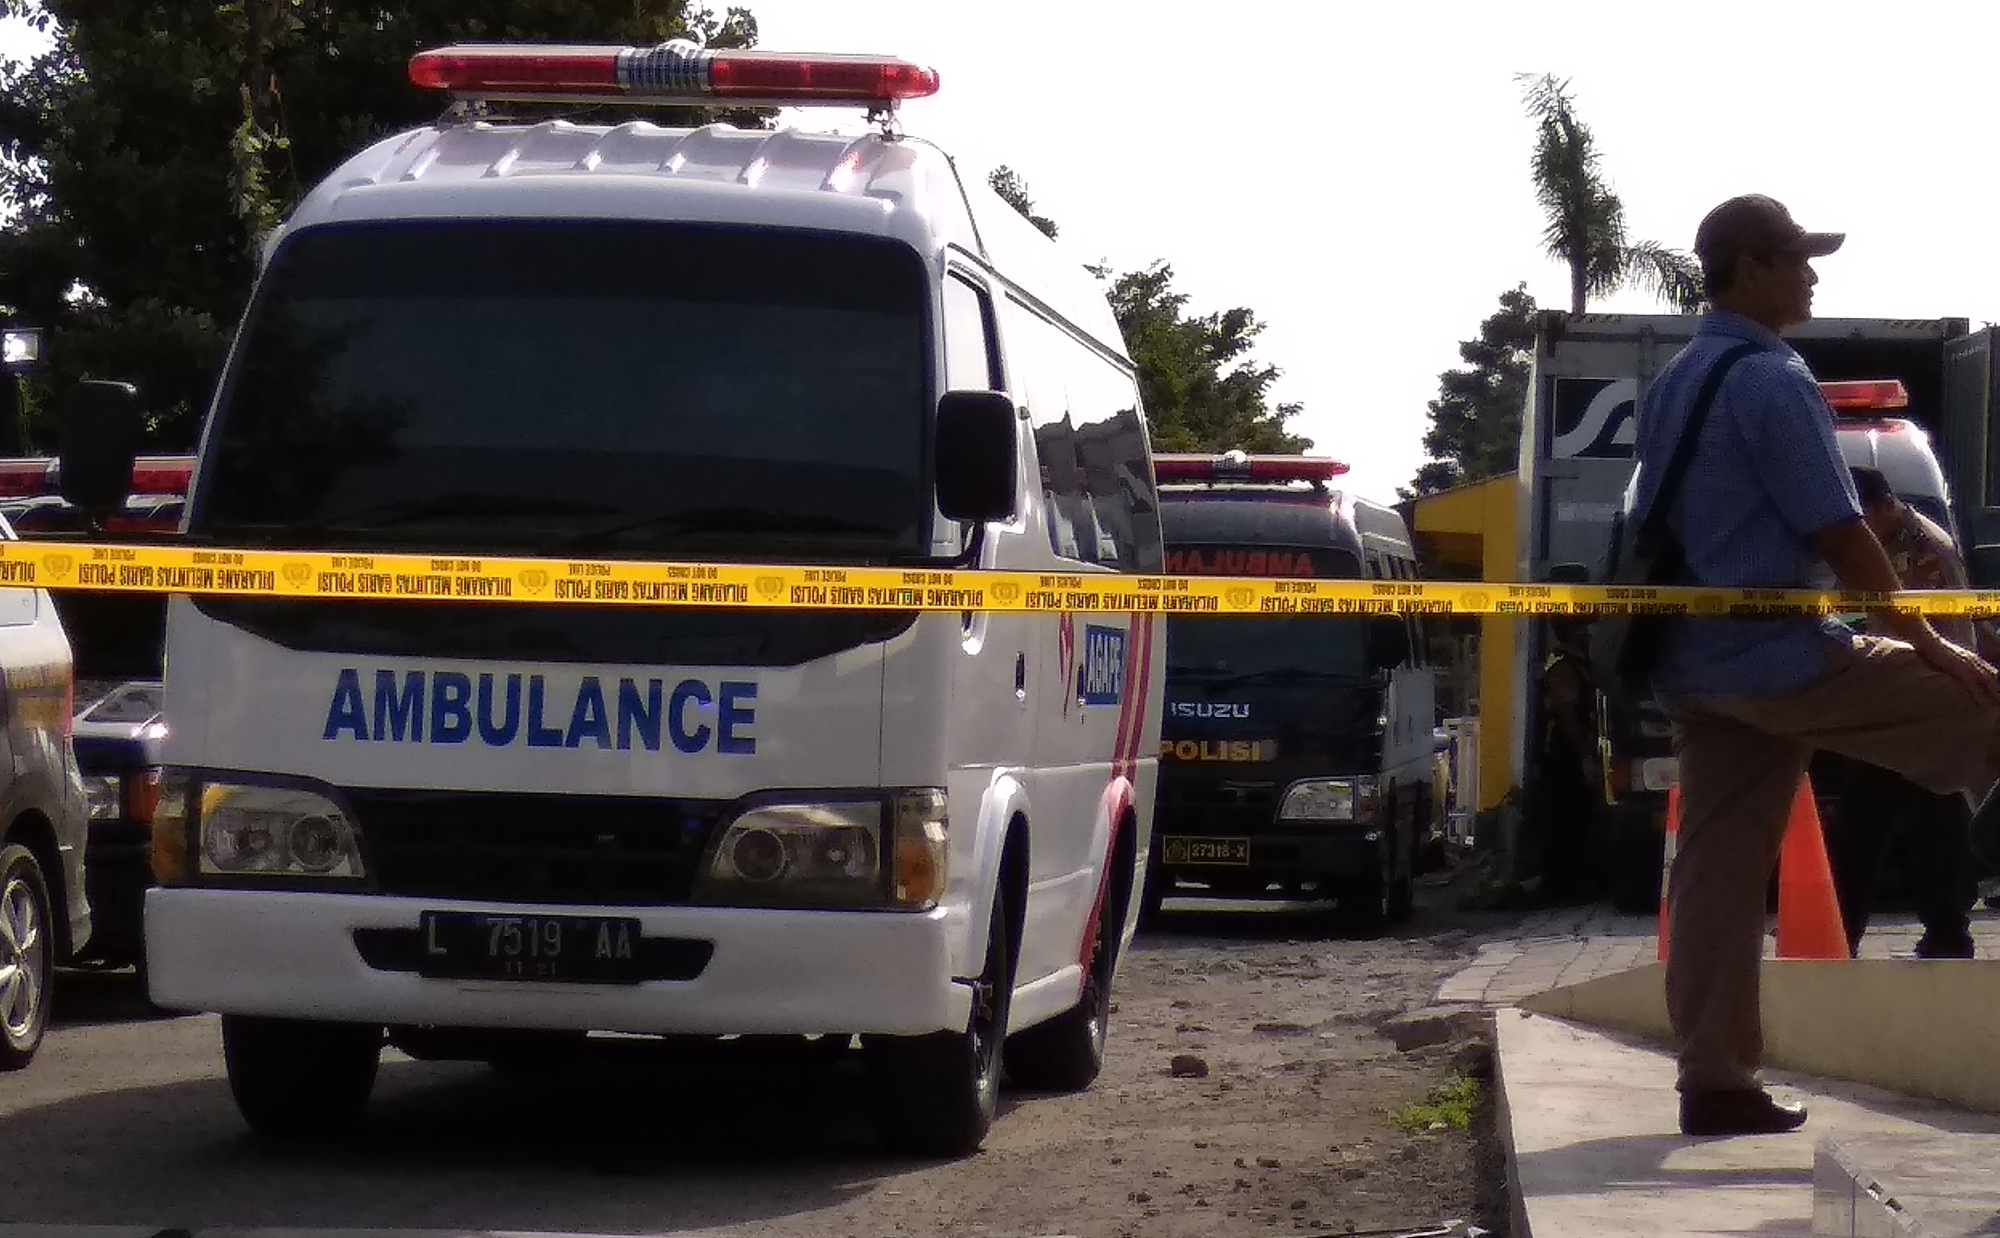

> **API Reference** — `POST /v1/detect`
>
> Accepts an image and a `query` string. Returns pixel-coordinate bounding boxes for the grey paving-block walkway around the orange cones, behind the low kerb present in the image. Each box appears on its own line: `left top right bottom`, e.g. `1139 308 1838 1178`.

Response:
1436 908 2000 1006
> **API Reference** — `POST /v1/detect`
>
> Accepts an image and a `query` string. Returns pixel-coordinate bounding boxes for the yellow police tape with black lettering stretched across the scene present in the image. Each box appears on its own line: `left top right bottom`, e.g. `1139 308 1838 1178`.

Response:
0 540 2000 618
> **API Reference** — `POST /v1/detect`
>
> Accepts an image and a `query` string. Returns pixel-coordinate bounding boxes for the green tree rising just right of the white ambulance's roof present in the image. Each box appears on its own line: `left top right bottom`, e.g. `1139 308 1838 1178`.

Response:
988 166 1312 454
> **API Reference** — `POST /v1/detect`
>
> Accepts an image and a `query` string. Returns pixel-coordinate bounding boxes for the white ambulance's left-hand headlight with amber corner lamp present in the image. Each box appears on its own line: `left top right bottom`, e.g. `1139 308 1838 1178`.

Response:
196 782 364 880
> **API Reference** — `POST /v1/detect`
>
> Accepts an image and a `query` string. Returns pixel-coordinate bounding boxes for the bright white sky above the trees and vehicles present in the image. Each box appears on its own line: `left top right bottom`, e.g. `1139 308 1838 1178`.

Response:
0 0 2000 498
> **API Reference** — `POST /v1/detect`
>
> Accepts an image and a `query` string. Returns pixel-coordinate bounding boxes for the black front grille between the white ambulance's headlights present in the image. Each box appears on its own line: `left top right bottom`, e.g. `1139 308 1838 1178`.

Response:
346 790 722 906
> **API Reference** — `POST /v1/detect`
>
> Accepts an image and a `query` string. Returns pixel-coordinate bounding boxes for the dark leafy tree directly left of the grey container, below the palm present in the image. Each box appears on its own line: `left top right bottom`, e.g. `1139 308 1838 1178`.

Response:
1402 284 1536 498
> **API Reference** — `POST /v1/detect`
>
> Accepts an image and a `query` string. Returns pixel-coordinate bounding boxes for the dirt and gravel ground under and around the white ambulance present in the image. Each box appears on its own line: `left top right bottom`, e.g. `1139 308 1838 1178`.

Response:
15 872 1504 1238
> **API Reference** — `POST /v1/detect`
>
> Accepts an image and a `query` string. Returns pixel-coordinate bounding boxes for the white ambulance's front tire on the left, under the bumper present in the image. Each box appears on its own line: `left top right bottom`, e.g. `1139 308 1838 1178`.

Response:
222 1014 382 1138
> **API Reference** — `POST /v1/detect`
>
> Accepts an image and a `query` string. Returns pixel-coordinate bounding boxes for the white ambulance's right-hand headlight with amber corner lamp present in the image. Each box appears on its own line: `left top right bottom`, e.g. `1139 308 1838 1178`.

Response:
696 790 944 910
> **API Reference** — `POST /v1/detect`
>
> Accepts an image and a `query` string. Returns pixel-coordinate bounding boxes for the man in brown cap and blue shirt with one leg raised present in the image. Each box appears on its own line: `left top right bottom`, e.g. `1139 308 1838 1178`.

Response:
1634 194 2000 1136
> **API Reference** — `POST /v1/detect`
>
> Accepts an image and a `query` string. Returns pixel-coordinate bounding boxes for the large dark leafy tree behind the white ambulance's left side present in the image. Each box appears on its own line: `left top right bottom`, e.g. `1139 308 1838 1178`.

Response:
0 0 768 448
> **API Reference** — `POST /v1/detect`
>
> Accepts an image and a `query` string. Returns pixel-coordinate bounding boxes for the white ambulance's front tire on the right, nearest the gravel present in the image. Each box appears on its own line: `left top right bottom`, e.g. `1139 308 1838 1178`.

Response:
862 890 1016 1158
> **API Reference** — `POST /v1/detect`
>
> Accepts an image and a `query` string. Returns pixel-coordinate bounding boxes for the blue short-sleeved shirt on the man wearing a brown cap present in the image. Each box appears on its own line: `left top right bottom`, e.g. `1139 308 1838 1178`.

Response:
1634 312 1860 700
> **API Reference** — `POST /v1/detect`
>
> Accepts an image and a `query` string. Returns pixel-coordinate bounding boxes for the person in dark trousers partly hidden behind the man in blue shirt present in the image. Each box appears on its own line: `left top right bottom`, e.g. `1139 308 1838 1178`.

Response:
1826 468 1992 958
